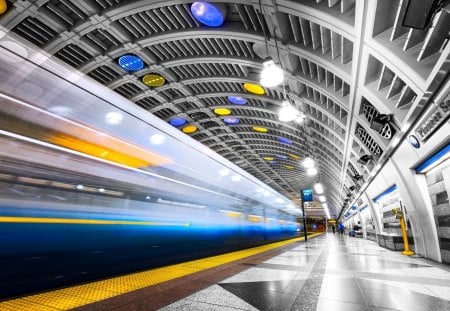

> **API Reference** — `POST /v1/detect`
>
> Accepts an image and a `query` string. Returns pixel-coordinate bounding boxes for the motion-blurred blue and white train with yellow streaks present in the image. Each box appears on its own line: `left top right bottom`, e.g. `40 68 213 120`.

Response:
0 40 302 298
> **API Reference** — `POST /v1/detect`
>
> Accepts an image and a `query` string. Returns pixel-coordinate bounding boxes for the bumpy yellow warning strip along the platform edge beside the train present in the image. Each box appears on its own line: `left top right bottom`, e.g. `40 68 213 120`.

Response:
0 233 321 311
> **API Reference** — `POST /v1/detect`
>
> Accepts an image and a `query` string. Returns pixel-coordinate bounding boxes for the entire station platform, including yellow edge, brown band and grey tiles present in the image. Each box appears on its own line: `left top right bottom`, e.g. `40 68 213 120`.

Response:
0 233 450 311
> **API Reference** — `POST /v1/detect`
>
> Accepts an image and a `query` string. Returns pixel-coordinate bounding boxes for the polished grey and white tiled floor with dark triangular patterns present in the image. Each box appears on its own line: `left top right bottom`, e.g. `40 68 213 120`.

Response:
161 233 450 311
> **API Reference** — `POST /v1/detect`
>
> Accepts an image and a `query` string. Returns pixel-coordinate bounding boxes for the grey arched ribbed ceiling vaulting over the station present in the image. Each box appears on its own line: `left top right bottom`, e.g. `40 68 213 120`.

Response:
0 0 449 215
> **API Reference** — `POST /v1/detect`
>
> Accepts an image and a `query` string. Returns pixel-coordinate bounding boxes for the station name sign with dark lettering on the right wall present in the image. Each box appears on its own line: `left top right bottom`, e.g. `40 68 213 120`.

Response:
415 96 450 142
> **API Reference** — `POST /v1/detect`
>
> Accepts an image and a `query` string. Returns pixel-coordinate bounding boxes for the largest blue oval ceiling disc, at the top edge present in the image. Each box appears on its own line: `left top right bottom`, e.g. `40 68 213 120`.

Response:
191 1 226 27
